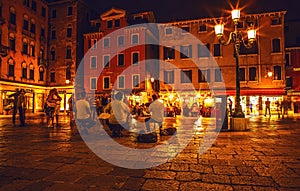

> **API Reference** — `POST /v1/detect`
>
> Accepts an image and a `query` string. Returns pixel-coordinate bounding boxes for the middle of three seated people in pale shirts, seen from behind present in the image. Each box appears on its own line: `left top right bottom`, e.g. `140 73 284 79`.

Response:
104 92 130 137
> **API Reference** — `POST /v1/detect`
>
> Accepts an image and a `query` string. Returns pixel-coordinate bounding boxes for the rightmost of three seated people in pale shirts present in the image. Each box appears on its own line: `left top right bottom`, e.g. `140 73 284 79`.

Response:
145 94 165 135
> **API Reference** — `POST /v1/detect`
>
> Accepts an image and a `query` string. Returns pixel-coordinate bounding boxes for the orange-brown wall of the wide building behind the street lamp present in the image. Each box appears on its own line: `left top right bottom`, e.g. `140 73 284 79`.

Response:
160 12 285 93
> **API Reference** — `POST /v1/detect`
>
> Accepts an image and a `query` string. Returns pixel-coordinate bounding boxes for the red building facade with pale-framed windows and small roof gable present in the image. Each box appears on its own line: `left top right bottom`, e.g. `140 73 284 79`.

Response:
84 8 159 103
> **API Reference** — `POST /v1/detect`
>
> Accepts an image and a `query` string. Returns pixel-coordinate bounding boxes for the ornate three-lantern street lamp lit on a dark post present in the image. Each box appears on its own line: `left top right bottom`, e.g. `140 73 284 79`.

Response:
215 9 256 118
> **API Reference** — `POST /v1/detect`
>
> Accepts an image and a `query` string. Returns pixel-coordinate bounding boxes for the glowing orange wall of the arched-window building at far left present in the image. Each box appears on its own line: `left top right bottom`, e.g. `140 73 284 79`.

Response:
0 0 48 114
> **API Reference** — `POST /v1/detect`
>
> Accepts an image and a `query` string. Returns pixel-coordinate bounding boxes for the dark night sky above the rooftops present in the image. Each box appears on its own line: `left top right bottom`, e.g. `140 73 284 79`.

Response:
86 0 300 22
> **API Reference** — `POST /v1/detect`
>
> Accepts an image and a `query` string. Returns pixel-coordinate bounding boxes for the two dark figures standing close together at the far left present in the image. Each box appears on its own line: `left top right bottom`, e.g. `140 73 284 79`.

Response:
9 88 26 127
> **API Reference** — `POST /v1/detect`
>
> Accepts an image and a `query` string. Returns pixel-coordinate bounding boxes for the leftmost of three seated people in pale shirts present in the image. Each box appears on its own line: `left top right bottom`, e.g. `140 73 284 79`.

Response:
75 92 92 134
